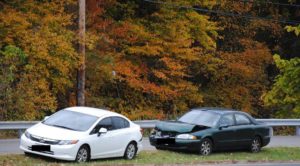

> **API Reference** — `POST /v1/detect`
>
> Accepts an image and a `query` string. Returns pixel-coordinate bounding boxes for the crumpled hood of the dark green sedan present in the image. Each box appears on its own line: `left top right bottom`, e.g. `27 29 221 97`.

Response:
156 121 196 133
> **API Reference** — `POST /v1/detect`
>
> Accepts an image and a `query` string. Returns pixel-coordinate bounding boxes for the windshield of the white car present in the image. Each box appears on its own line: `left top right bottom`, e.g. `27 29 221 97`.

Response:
42 110 98 131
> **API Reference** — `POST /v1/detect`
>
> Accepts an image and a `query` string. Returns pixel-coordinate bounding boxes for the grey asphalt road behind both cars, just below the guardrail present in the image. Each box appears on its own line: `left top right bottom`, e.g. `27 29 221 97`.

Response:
0 136 300 154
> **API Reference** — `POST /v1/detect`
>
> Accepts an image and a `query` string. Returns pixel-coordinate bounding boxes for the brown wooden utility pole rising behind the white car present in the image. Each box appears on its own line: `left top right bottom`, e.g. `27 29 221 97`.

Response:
77 0 85 106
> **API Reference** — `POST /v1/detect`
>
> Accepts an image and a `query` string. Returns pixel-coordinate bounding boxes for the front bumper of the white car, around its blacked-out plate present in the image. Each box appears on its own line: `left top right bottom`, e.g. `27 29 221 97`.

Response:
20 134 79 161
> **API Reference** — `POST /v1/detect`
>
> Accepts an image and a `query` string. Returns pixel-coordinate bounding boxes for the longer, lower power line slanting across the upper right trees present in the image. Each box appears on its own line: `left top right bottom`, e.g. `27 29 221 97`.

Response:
144 0 300 25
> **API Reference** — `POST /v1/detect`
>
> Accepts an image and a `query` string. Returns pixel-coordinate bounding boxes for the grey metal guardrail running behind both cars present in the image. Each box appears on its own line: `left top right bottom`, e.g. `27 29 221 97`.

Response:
0 119 300 136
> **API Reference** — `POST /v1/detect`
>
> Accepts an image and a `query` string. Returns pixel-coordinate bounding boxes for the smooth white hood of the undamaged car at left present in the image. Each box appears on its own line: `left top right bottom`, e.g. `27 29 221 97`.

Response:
27 123 85 140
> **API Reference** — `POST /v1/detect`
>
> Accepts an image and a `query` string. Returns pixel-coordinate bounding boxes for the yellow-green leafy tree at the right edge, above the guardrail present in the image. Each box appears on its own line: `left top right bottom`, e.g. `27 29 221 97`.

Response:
264 55 300 118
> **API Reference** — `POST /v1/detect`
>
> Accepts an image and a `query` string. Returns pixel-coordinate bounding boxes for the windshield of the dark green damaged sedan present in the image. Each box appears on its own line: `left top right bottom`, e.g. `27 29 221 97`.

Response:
178 110 221 127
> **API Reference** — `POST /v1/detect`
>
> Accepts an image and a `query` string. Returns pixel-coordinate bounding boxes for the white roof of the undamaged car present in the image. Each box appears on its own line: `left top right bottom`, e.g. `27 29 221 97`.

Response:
64 107 124 117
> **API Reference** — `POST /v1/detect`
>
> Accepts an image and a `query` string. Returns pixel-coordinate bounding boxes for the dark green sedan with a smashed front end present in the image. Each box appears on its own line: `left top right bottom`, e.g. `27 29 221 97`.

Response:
149 108 272 155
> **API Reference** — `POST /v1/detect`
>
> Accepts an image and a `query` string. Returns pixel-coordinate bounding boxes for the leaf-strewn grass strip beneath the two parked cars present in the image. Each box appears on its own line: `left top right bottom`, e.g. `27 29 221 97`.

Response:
0 147 300 166
